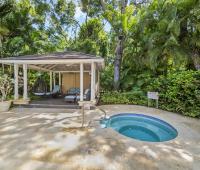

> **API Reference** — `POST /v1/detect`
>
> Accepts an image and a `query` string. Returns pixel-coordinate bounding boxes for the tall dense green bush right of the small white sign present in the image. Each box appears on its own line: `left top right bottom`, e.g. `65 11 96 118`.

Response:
147 71 200 117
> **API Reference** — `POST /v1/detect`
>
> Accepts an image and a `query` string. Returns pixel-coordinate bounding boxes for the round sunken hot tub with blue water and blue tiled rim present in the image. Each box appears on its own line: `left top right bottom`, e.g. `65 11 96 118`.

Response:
101 113 178 142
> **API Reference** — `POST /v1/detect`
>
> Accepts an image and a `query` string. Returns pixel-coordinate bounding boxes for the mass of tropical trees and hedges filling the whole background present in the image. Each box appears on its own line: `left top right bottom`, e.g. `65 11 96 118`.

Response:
0 0 200 117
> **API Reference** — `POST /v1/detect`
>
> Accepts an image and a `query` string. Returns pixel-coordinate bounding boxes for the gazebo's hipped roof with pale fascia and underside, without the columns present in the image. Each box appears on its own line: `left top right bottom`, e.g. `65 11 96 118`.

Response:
0 51 104 72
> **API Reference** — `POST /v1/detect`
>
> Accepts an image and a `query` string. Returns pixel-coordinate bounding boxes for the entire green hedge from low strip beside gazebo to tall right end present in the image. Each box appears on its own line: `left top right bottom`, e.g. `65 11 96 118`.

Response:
100 71 200 117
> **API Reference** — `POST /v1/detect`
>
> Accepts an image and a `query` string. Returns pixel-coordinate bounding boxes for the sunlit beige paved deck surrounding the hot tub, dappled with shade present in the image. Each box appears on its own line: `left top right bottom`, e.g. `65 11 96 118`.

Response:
0 105 200 170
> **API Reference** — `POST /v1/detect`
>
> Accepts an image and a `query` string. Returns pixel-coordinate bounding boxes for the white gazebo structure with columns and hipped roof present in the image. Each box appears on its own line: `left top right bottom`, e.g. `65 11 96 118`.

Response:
0 52 104 104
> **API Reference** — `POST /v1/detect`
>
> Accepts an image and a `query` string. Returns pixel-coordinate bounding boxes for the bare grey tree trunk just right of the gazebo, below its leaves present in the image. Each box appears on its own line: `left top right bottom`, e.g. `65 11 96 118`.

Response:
114 37 123 90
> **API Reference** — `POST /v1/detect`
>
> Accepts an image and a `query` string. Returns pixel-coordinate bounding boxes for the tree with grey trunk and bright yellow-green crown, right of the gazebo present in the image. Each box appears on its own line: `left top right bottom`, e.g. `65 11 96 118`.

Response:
82 0 135 90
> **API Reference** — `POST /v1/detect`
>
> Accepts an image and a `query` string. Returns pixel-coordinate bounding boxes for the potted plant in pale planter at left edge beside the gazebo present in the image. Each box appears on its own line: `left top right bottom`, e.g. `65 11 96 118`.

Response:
0 73 12 112
